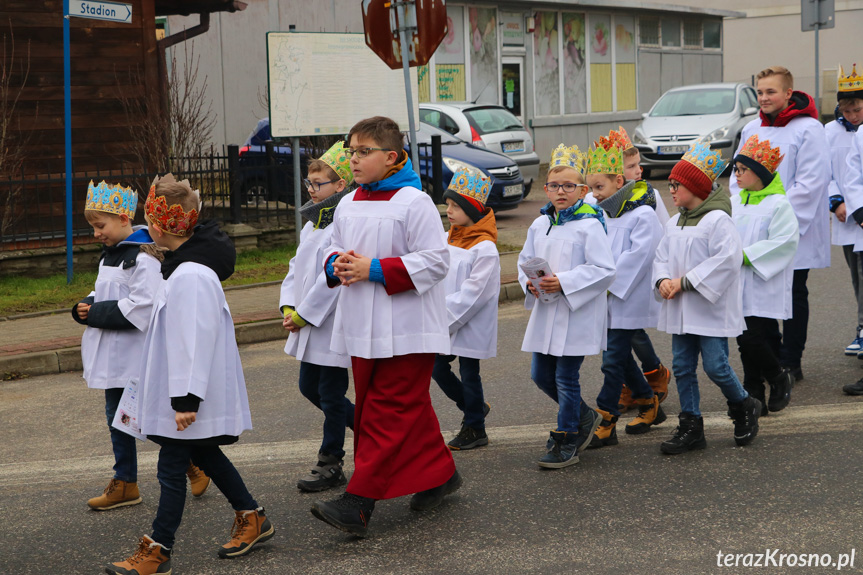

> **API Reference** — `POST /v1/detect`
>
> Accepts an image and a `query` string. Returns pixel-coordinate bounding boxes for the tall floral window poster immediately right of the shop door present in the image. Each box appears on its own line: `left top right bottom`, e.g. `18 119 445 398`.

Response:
533 12 560 116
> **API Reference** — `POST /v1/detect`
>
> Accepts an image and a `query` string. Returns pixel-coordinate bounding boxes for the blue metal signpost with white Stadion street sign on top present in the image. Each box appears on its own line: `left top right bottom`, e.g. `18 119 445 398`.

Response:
63 0 132 284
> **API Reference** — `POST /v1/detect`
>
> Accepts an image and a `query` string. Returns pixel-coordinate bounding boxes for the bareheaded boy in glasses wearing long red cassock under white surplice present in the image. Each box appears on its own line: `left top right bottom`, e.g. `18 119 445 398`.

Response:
312 116 462 537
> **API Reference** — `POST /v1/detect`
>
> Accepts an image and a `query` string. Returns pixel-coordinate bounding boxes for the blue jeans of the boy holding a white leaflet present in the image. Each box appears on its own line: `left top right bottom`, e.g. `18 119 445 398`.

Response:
530 352 584 433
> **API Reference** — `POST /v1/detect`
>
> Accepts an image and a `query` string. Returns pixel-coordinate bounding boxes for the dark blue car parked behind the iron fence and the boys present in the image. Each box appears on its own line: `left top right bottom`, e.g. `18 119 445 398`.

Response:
233 118 524 211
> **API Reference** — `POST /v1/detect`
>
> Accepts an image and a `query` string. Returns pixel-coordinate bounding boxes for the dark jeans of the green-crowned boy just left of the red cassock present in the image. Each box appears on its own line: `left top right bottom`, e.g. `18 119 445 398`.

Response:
300 361 354 459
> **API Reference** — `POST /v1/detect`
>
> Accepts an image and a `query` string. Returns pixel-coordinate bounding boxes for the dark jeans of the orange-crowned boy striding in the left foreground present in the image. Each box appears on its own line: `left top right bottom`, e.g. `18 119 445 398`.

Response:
152 442 258 547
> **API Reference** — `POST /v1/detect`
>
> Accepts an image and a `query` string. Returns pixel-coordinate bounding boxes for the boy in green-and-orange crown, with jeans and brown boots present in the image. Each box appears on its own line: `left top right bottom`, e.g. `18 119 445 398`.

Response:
587 131 668 448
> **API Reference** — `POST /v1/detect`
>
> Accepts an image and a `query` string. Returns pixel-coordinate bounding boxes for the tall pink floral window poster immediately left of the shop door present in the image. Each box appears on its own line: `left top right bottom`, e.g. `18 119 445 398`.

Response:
468 8 498 104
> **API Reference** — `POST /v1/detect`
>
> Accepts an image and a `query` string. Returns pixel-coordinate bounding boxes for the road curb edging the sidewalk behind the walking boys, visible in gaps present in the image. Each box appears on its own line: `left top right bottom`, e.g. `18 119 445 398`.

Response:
0 282 524 379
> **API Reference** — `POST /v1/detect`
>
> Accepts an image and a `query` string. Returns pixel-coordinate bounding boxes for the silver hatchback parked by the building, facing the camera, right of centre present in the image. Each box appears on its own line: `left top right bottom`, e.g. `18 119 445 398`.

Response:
632 83 758 177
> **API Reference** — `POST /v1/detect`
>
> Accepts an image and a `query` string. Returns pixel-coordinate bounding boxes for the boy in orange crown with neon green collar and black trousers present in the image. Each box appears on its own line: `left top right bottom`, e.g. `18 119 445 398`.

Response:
731 134 800 416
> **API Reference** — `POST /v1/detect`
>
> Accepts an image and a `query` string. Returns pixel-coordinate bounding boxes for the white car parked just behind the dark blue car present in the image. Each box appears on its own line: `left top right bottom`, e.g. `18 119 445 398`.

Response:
419 102 539 196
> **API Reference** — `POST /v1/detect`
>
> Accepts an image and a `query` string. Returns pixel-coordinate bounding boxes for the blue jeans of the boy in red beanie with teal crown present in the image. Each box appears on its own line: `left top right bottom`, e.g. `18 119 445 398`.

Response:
671 334 748 417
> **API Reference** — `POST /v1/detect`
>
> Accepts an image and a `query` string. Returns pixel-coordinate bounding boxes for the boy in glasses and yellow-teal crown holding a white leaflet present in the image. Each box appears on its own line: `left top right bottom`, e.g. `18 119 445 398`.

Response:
518 144 617 469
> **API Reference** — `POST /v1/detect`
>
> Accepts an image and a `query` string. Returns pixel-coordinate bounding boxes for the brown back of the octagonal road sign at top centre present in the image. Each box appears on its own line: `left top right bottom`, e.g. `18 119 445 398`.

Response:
363 0 447 70
